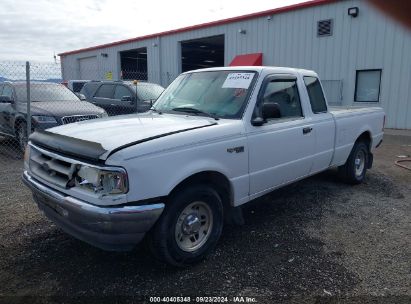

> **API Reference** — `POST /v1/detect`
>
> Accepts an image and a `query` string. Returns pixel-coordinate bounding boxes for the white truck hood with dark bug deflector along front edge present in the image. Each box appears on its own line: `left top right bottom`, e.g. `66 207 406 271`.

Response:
30 113 217 161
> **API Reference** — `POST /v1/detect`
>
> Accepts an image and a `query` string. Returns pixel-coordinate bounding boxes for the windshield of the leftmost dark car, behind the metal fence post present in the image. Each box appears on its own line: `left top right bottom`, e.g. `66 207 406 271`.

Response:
16 82 79 102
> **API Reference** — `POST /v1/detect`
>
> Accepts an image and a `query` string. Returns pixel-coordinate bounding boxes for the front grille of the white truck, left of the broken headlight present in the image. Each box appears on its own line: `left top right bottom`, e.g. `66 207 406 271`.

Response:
29 145 76 188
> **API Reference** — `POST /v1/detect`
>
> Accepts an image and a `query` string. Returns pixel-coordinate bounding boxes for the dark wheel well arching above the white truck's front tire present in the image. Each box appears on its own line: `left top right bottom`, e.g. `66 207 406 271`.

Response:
170 171 233 207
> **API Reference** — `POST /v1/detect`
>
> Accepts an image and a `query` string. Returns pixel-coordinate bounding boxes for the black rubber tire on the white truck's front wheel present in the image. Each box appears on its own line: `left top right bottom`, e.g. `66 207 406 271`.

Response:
148 184 224 267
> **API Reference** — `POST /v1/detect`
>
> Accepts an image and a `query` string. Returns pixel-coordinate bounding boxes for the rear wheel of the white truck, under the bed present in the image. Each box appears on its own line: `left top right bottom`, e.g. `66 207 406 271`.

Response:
338 141 369 185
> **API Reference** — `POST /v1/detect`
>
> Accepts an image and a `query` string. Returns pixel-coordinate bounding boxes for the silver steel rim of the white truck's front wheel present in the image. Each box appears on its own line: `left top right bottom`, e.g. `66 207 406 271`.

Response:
175 202 213 252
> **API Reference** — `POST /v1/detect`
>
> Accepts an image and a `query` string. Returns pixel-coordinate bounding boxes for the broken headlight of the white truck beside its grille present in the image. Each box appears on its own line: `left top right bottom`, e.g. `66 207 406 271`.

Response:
76 166 128 195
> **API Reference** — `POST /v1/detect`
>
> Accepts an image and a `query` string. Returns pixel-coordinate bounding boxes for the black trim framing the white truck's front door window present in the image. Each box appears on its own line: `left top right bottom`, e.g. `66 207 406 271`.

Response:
251 73 305 124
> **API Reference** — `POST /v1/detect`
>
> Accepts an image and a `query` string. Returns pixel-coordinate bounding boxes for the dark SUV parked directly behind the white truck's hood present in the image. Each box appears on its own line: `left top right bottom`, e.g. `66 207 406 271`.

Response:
80 81 164 115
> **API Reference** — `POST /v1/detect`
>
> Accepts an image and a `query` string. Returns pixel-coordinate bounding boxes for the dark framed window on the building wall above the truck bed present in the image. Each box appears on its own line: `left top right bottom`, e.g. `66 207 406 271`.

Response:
354 70 381 102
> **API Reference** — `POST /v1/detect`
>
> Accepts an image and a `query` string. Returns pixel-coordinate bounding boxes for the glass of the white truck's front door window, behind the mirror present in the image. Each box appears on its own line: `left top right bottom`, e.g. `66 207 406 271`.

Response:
262 78 303 118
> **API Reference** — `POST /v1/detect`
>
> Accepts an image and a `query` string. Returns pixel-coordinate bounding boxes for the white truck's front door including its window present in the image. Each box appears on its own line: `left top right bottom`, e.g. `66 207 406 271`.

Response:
247 74 315 199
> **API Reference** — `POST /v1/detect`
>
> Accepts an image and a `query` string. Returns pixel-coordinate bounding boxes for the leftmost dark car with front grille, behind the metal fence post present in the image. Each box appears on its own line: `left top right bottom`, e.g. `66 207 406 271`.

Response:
0 82 107 150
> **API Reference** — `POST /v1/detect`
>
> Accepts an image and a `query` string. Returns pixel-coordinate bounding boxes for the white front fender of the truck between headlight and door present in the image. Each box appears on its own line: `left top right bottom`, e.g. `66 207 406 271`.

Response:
116 137 249 204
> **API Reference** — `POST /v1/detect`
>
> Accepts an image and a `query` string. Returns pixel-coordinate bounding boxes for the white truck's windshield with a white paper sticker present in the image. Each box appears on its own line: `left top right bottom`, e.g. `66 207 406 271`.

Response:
153 70 257 118
